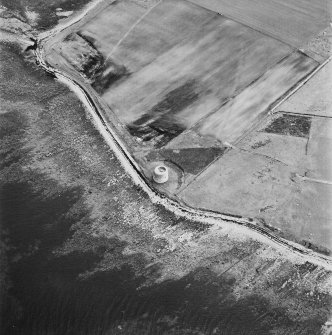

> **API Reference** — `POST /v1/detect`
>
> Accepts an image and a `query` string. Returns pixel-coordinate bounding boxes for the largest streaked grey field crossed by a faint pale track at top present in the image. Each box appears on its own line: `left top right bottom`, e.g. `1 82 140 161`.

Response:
74 1 300 146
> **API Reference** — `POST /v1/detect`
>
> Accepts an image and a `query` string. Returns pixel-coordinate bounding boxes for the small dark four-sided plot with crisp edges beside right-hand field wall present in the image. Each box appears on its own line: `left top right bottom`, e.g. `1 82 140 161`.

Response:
263 114 311 138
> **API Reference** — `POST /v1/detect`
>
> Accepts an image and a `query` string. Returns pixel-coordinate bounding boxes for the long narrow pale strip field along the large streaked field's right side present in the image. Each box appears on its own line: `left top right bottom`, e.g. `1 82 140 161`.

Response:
196 52 316 142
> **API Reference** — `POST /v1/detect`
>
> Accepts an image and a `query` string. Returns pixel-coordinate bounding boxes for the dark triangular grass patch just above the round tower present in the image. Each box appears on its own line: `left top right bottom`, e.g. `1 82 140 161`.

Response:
147 147 225 174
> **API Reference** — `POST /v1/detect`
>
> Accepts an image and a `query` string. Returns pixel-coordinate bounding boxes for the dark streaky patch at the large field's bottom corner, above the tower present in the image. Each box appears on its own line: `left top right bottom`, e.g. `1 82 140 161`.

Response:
127 80 198 148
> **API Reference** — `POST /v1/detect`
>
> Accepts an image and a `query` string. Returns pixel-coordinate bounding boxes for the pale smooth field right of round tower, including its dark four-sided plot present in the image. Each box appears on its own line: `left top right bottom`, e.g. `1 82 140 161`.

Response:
181 111 332 249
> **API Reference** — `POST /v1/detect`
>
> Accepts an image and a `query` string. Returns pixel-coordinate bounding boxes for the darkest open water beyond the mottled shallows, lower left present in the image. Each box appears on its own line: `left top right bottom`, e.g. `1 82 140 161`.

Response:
0 183 282 334
